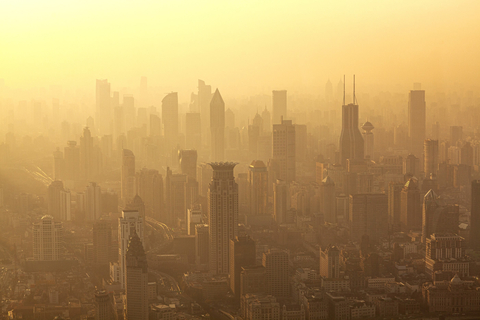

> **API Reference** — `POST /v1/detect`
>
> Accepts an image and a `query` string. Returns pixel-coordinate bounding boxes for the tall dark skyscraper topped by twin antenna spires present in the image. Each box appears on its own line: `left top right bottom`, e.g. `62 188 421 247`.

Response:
339 78 365 167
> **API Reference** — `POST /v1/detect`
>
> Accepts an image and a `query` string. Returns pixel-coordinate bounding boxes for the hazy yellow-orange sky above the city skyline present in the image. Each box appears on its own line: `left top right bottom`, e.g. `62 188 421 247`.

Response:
0 0 480 93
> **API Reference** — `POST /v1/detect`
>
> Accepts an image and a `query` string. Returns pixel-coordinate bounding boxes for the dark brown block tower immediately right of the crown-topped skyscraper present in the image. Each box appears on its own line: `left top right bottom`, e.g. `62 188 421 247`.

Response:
229 236 256 300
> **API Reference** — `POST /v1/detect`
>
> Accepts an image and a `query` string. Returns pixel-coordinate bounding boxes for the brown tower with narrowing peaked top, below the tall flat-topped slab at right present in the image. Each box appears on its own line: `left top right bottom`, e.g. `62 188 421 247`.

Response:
400 178 422 232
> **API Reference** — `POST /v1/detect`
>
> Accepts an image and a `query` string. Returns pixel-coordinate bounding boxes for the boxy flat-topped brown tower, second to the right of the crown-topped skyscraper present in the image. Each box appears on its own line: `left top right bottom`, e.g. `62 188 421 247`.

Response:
262 249 290 298
